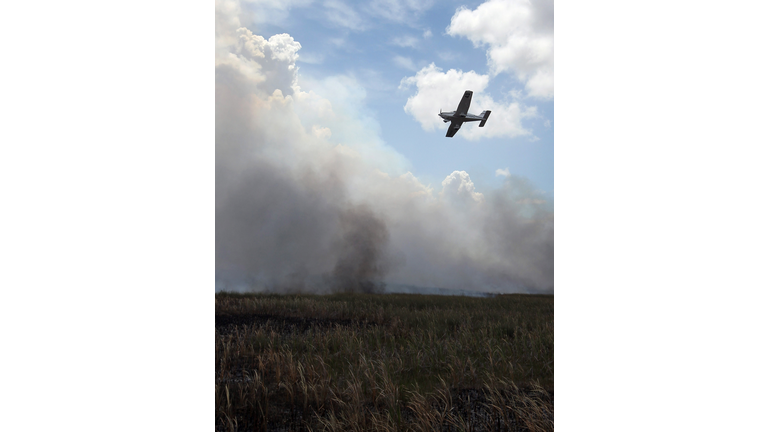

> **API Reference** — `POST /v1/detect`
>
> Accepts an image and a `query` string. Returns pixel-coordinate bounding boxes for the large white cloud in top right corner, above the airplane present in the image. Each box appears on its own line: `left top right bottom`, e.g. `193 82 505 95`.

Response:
446 0 555 99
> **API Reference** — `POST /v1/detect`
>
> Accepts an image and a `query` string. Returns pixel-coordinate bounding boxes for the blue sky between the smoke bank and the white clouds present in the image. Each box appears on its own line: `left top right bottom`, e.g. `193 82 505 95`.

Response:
242 1 554 199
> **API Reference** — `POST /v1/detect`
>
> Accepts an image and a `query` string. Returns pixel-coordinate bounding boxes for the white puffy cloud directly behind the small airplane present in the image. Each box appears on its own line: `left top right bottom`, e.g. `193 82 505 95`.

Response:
400 63 537 140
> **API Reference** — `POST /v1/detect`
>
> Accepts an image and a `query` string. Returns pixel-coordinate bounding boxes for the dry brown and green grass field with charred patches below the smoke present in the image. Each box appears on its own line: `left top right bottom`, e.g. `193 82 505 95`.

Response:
216 293 554 431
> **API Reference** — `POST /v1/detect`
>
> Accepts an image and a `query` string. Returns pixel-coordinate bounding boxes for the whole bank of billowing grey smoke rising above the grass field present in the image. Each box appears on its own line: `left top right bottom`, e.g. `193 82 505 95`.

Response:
215 1 554 293
